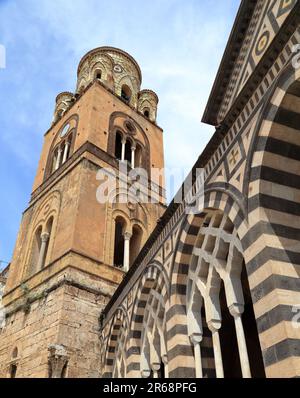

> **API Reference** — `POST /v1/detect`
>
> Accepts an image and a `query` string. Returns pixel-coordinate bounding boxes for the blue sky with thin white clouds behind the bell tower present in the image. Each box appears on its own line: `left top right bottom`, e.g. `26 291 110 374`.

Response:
0 0 240 268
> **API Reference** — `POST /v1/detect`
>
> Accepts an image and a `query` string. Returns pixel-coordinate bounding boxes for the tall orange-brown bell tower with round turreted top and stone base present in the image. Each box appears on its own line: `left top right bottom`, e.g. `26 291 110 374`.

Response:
0 47 165 377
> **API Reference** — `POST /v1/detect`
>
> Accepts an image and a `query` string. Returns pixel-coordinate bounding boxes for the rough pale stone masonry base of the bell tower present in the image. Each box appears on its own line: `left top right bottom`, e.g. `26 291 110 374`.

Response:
0 276 108 378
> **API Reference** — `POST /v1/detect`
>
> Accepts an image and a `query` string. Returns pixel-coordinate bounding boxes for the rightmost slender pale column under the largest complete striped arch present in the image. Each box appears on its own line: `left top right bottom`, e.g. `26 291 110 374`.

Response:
229 304 251 379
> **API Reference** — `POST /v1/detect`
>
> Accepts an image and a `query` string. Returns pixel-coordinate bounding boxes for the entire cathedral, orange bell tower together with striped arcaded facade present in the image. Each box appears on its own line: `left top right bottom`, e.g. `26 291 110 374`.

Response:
0 0 300 378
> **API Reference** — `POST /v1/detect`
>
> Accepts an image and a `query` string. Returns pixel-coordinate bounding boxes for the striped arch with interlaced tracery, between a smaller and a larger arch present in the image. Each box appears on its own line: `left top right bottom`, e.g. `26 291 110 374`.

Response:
128 262 169 377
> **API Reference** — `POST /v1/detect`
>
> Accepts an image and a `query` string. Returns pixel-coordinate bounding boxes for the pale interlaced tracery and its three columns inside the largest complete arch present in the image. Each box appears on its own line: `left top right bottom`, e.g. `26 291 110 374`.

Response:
187 211 251 377
